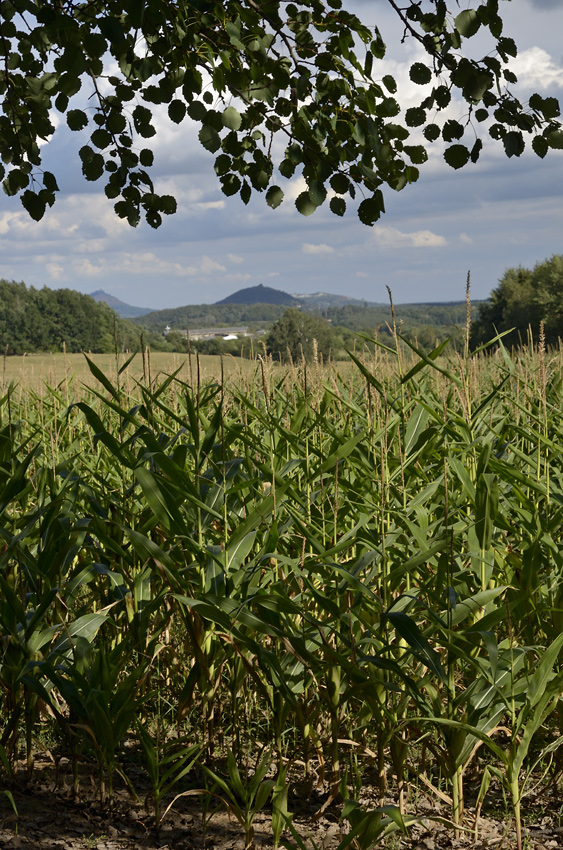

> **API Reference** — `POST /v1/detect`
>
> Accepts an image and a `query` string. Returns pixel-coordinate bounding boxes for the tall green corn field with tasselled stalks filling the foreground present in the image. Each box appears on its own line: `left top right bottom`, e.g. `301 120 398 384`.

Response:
0 341 563 850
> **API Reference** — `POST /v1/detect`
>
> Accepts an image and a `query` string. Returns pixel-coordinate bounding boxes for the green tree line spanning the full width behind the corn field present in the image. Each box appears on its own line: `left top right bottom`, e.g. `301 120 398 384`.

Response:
4 254 563 362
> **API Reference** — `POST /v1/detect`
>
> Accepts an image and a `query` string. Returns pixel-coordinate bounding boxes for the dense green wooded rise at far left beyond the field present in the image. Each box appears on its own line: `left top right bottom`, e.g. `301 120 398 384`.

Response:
0 280 164 354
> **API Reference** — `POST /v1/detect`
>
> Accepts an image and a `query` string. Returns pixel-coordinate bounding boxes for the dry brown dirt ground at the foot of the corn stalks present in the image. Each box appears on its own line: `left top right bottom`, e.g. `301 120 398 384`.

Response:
0 761 563 850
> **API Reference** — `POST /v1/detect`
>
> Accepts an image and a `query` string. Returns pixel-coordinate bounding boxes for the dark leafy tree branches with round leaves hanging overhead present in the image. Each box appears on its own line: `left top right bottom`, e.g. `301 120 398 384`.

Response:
0 0 563 227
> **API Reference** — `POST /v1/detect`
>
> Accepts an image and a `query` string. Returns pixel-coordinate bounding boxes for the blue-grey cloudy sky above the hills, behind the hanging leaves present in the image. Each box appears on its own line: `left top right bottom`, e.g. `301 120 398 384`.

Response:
0 0 563 309
